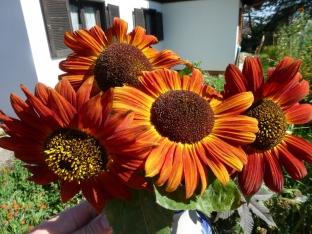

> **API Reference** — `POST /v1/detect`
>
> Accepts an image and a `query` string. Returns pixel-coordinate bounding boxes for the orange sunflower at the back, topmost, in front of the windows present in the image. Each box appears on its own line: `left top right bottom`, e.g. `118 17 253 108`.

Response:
59 18 191 95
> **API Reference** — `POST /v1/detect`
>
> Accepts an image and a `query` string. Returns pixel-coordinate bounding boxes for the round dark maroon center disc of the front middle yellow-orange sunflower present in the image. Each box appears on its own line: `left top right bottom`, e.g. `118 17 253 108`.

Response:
151 90 214 144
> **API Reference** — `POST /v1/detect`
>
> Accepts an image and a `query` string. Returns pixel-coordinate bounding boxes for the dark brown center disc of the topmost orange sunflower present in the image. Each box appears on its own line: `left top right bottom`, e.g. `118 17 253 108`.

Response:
94 43 153 91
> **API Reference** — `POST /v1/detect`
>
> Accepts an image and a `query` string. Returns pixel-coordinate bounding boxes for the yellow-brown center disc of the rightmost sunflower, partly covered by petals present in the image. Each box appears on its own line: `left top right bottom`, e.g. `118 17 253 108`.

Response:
245 99 287 150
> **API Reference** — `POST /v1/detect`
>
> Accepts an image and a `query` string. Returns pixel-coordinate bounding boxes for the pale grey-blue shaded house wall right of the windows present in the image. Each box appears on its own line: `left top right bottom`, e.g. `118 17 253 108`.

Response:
162 0 240 71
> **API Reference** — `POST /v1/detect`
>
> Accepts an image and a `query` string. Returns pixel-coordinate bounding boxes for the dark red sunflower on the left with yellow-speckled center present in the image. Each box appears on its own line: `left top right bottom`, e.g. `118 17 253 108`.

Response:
0 78 154 212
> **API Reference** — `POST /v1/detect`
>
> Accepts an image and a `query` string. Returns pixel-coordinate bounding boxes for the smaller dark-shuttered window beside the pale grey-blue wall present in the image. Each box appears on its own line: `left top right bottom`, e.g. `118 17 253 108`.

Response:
133 8 164 41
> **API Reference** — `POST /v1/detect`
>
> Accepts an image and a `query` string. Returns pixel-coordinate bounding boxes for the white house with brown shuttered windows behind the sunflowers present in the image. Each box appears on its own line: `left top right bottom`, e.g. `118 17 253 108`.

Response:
0 0 259 116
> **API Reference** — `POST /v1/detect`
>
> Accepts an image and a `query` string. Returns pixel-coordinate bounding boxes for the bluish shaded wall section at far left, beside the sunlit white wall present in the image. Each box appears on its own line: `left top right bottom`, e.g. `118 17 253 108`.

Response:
0 1 38 117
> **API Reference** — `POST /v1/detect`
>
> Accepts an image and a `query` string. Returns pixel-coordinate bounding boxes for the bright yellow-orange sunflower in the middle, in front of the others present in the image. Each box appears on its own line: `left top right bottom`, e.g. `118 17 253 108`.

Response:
113 69 258 198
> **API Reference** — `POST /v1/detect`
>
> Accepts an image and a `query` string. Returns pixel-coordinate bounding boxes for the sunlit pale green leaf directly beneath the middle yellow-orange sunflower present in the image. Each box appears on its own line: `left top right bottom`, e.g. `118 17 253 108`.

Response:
154 180 242 216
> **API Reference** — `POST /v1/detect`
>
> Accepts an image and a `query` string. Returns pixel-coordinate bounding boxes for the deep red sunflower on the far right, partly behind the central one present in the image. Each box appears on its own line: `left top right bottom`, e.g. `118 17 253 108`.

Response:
224 57 312 195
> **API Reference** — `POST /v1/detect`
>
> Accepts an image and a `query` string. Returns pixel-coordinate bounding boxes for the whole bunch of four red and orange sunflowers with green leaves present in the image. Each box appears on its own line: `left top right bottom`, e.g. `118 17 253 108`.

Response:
0 18 312 234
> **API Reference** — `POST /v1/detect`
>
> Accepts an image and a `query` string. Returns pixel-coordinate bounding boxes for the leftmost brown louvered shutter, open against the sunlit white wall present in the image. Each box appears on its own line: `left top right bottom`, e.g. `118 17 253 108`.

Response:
41 0 72 58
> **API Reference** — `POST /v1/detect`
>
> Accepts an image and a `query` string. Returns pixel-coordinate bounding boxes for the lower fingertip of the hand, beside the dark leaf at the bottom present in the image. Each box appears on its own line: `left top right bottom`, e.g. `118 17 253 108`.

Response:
73 214 113 234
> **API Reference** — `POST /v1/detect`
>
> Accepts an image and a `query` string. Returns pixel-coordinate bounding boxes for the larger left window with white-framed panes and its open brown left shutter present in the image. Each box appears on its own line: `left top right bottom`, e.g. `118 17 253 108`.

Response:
40 0 107 58
